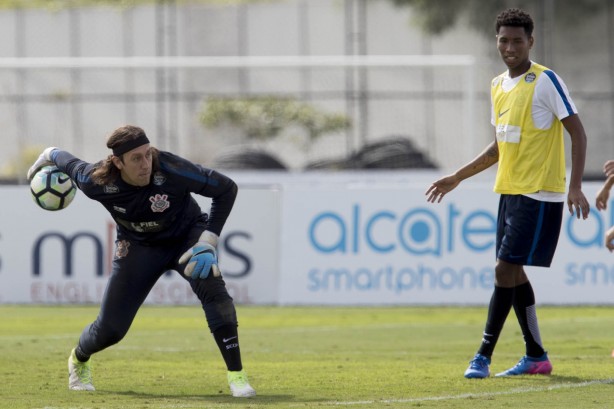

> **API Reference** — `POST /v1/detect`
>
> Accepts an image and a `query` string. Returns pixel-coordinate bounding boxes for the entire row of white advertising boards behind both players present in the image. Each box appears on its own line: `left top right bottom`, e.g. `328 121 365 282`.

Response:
0 176 614 305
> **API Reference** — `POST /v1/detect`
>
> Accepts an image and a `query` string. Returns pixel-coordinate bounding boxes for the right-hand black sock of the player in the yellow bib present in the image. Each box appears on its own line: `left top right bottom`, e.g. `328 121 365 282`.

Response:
514 282 545 358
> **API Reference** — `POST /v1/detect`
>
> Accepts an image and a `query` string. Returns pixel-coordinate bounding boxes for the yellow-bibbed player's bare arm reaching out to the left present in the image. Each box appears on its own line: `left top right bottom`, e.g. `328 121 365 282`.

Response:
425 141 499 203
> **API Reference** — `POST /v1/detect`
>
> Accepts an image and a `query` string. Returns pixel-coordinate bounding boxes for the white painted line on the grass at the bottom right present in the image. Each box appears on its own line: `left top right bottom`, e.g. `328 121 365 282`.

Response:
290 379 614 406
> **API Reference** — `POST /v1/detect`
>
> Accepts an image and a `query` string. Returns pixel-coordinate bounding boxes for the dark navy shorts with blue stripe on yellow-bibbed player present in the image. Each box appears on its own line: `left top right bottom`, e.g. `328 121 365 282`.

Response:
497 195 563 267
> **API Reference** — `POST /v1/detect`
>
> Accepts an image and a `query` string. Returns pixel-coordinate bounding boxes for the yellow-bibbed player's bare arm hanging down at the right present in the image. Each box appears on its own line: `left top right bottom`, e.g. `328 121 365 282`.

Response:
561 114 590 219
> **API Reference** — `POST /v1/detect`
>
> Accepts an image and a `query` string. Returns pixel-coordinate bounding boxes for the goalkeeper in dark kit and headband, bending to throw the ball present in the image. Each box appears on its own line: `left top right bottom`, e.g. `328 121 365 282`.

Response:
28 125 256 397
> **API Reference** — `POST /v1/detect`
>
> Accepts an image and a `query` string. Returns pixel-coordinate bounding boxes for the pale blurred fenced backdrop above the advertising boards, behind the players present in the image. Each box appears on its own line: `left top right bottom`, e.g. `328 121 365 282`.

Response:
0 0 614 181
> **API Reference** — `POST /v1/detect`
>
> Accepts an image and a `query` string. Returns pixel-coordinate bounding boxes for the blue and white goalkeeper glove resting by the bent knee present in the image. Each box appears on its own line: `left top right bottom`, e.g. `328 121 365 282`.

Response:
179 231 221 279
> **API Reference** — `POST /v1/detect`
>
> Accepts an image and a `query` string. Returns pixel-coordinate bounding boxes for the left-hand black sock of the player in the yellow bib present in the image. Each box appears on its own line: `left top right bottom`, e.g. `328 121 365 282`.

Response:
478 286 514 358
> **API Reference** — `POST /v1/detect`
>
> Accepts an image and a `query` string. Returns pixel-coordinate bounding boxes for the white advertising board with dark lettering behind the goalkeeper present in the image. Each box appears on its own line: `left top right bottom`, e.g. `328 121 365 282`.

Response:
0 186 279 304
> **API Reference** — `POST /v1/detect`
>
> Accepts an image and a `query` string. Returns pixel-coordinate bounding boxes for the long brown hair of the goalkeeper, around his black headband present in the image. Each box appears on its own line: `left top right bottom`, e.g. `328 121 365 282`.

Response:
92 125 158 185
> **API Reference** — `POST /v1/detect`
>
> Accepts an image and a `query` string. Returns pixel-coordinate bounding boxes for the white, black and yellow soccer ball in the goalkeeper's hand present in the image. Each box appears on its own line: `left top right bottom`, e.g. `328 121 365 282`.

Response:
30 166 77 210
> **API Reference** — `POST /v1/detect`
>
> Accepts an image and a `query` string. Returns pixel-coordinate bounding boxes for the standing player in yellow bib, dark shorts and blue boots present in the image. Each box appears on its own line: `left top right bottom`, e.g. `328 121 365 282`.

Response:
426 8 589 378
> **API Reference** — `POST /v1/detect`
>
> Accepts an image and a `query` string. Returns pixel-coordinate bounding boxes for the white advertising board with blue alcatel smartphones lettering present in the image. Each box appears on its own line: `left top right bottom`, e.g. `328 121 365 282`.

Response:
279 182 614 304
